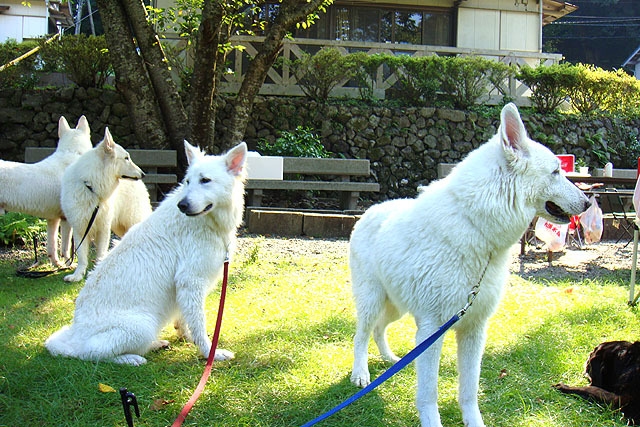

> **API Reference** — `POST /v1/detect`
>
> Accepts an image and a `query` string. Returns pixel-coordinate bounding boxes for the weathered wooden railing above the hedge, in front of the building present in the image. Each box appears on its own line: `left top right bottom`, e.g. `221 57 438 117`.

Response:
220 36 562 105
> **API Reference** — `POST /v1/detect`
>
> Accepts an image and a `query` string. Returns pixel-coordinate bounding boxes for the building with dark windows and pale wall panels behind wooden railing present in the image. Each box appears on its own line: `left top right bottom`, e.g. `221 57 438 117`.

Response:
211 0 577 102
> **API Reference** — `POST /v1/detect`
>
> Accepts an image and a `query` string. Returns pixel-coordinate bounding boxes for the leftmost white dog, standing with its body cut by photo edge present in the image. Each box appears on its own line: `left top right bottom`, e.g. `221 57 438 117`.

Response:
0 116 91 267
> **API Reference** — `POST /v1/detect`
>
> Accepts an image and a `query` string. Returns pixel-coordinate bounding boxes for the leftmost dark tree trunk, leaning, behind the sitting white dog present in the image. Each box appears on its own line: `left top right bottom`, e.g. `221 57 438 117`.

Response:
97 0 167 148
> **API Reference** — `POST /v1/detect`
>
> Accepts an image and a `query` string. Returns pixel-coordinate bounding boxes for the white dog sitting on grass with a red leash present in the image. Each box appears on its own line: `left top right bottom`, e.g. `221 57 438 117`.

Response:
45 142 247 365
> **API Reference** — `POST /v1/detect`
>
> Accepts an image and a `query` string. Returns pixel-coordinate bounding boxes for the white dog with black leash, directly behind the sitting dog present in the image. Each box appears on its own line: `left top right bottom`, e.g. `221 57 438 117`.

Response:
60 128 151 282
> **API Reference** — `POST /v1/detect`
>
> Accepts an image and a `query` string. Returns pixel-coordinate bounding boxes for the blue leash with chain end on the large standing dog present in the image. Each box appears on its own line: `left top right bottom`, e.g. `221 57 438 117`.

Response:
302 256 491 427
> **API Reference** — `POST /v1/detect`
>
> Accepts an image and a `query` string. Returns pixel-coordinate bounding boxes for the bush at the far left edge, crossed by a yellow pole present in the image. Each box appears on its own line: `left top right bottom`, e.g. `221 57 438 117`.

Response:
0 40 38 89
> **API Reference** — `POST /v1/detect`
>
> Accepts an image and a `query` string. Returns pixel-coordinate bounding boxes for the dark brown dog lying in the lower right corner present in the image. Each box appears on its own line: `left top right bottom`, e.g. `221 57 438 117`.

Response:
554 341 640 425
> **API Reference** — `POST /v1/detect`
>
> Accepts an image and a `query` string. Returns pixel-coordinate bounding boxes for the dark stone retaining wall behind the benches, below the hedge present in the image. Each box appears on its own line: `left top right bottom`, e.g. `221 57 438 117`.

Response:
0 87 640 199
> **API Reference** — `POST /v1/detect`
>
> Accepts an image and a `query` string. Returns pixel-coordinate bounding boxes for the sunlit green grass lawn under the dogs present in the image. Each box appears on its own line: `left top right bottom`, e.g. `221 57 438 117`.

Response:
0 238 640 427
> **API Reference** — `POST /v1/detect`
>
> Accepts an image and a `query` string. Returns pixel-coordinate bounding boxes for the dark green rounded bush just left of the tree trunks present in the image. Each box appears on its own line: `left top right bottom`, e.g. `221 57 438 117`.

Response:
40 34 112 88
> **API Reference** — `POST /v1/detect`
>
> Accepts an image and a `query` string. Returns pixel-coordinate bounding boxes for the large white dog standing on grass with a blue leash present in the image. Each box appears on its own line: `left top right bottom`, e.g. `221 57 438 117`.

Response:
350 104 589 427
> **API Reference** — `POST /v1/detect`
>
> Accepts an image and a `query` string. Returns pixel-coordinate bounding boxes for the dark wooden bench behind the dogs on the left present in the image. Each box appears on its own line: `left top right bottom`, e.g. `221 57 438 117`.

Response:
24 147 178 205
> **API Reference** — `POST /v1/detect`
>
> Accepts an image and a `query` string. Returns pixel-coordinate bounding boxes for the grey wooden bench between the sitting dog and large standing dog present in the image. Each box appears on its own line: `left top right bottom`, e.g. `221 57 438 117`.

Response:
245 157 380 211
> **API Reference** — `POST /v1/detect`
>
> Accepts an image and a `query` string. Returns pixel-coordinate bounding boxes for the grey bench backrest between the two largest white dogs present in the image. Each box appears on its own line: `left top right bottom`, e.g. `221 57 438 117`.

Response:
282 157 371 176
